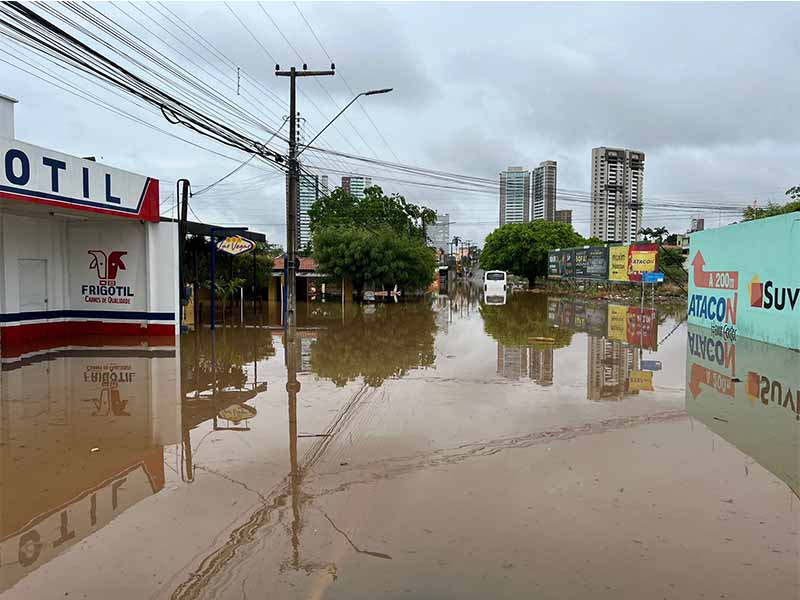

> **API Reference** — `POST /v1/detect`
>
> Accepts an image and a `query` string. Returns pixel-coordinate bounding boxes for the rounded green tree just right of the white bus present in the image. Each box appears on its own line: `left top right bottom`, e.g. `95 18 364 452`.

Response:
481 221 586 287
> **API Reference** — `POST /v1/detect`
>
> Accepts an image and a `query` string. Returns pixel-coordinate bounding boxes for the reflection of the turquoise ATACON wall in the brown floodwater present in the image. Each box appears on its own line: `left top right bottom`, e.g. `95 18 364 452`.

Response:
686 325 800 497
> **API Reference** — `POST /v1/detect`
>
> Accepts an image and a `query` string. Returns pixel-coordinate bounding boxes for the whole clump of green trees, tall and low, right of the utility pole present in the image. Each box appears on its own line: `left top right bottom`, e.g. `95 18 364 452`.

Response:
309 186 436 291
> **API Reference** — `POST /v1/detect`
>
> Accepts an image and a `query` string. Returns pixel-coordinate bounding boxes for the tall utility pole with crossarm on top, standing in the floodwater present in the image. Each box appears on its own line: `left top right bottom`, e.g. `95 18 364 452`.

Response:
275 63 335 329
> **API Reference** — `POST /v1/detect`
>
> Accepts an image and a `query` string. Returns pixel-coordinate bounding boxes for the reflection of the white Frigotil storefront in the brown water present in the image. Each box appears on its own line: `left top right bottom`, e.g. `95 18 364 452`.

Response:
0 345 180 591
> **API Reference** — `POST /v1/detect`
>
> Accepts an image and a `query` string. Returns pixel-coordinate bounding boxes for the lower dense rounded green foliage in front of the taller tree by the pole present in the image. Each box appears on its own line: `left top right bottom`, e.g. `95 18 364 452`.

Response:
314 225 436 294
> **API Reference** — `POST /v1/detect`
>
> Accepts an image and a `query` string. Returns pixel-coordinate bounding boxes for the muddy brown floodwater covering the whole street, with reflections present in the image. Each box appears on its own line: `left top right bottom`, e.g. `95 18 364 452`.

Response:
0 288 800 600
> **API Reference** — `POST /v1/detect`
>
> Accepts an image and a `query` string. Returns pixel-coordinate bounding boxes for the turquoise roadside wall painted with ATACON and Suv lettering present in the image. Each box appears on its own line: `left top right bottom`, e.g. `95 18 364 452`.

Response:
688 213 800 350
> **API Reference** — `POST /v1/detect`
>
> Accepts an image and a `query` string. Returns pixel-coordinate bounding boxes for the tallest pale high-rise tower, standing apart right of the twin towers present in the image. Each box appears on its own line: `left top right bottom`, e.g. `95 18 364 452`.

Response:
591 146 644 243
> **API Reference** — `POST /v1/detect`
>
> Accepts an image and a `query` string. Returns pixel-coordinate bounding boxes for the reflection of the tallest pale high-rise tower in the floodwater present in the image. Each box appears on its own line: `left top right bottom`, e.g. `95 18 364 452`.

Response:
586 335 639 400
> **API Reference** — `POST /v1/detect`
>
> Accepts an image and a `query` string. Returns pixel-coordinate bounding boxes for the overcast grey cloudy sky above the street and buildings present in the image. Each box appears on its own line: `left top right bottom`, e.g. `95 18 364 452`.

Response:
0 2 800 243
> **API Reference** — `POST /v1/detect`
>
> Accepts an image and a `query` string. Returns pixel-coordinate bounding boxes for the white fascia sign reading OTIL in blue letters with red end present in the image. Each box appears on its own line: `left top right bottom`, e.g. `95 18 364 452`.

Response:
0 138 159 222
